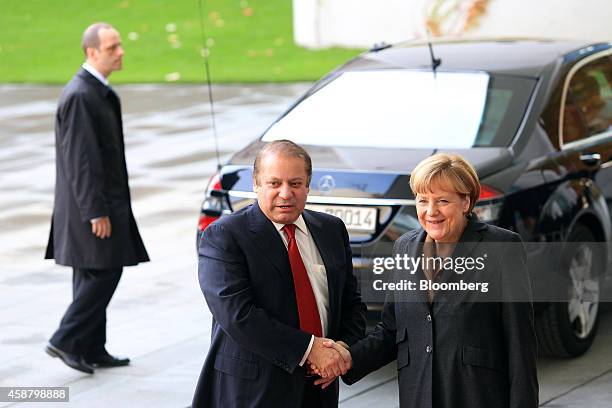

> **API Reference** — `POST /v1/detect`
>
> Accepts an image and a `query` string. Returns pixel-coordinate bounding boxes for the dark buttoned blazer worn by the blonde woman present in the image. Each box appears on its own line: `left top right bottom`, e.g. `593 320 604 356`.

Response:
343 221 538 408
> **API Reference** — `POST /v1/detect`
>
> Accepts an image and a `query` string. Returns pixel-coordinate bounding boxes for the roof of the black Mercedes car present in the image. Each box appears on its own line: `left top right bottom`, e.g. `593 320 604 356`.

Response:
340 38 611 77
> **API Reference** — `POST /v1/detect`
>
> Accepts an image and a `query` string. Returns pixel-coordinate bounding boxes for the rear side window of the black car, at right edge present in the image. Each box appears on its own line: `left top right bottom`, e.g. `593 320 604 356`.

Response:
563 56 612 144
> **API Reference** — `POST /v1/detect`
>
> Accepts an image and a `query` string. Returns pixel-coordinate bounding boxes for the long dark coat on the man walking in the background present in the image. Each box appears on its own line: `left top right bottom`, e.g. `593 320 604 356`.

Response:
45 69 149 269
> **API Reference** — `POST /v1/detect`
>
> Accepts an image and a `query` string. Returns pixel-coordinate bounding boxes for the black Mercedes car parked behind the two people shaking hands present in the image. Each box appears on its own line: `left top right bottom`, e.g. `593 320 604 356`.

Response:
199 40 612 356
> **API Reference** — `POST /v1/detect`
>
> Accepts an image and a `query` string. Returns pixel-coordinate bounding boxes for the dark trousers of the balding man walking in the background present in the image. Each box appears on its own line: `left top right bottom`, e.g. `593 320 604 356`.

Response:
51 268 123 356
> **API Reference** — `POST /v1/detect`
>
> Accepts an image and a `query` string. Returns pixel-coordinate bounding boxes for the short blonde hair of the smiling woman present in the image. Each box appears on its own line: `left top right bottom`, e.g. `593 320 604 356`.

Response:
410 153 480 214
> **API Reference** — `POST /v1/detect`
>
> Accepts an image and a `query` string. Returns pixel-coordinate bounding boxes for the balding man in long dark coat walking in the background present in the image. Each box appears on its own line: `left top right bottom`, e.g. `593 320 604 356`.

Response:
45 23 149 374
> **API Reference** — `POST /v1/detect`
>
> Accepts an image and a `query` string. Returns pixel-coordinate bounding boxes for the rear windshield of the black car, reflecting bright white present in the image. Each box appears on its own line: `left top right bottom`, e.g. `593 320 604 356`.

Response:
263 69 535 149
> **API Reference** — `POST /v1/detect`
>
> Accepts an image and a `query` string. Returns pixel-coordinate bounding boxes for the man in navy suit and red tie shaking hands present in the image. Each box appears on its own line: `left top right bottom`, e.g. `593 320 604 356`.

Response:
193 140 365 408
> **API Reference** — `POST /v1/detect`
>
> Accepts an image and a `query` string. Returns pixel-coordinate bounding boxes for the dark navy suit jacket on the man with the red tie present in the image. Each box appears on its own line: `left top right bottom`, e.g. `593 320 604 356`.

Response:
193 203 365 408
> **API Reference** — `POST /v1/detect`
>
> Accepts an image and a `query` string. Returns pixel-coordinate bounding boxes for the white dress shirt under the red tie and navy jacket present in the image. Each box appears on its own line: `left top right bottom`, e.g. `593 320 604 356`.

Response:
272 215 329 366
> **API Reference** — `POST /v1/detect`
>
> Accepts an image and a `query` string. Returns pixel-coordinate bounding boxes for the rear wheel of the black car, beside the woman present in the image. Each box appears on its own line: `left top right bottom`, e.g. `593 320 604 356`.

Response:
536 224 603 357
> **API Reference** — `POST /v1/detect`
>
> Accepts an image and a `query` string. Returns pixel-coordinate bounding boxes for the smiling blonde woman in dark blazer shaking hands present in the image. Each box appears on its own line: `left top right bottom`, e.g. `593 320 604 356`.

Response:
319 154 538 408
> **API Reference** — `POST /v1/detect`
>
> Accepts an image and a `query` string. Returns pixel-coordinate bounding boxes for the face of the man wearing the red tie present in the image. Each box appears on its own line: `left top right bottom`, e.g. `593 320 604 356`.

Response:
253 154 310 224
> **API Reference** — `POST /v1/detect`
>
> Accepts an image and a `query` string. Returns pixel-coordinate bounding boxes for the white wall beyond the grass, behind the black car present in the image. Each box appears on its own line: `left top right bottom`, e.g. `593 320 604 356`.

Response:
293 0 612 48
